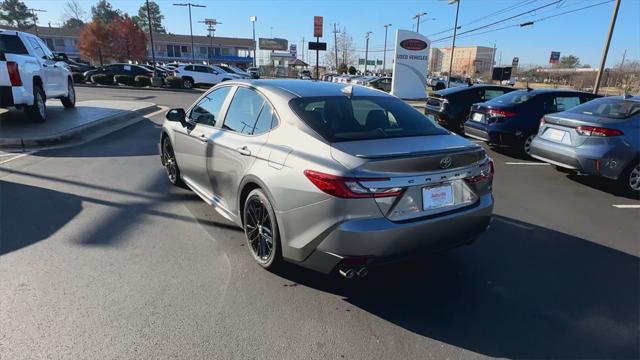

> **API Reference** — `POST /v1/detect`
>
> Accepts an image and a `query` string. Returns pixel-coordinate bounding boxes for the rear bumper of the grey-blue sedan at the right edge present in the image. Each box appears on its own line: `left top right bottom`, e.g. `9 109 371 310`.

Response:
531 137 636 179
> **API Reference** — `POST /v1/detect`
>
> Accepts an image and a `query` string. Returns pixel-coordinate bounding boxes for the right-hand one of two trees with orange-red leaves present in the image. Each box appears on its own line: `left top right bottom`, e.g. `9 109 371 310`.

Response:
108 14 147 61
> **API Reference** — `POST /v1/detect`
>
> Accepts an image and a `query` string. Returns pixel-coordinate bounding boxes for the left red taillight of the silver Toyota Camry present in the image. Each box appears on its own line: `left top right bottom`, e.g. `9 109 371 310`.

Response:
304 170 402 199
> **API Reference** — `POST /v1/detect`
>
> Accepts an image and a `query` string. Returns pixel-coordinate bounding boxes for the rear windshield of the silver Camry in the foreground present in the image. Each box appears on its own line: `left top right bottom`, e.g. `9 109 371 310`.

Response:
289 96 448 142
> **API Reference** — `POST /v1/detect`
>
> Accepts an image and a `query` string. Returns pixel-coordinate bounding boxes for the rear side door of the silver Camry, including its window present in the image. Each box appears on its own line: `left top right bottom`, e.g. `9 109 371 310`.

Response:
207 87 277 214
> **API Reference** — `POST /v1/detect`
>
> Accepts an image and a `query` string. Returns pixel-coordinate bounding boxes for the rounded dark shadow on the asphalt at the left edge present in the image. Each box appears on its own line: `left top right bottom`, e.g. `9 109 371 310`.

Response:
0 180 82 255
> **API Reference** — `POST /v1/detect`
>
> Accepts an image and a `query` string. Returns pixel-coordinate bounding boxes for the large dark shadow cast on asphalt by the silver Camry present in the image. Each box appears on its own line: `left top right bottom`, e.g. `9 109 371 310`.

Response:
278 216 640 359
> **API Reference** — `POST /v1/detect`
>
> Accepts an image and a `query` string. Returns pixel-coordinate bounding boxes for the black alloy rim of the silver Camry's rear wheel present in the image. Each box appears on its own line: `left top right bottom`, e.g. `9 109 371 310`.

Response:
245 196 274 263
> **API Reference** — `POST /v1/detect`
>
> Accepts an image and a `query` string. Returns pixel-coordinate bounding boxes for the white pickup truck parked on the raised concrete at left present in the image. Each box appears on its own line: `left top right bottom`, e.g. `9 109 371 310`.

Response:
0 29 76 122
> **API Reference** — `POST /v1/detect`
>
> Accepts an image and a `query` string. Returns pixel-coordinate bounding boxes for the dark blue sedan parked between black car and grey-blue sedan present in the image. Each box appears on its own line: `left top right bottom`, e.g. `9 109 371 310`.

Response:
464 89 600 155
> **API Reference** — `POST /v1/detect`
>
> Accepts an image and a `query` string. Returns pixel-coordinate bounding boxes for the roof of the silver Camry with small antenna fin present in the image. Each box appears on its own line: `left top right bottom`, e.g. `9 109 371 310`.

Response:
225 79 390 97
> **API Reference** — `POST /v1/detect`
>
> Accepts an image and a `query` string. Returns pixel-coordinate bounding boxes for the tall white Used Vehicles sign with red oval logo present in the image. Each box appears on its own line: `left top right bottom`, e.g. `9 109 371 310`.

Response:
391 30 431 99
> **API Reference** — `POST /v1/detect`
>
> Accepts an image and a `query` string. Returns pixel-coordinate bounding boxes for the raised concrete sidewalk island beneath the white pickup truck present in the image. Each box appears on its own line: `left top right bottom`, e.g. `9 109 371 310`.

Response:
0 100 158 151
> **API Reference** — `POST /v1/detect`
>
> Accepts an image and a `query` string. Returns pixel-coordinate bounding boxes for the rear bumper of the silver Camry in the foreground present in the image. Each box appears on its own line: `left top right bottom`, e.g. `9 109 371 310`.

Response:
300 194 493 273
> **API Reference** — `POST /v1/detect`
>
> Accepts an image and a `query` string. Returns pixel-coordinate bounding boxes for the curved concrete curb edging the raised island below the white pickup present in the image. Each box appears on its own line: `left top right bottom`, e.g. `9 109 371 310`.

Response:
0 104 160 151
